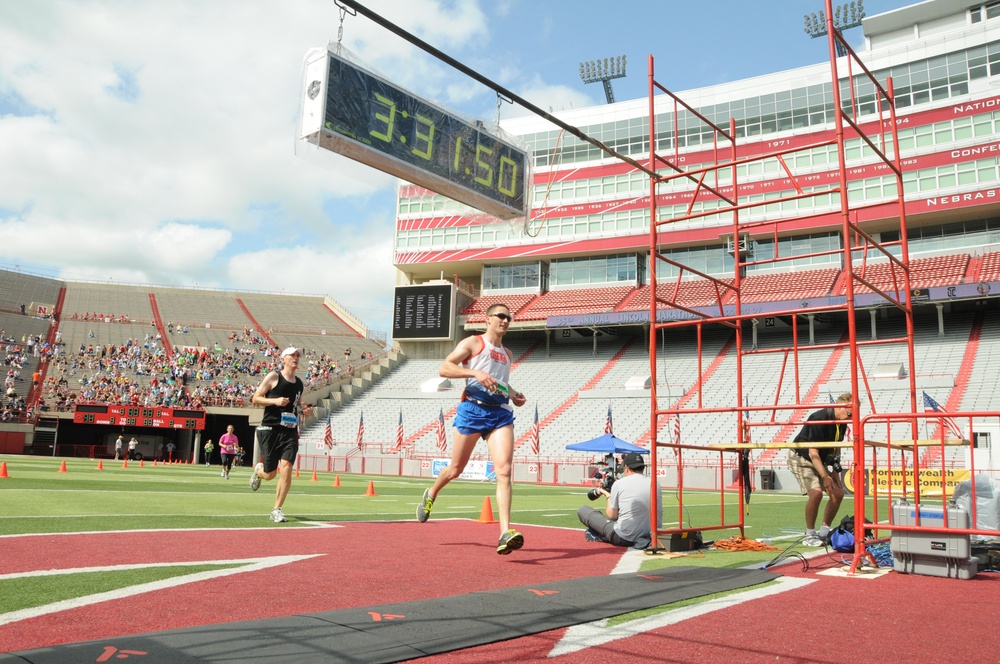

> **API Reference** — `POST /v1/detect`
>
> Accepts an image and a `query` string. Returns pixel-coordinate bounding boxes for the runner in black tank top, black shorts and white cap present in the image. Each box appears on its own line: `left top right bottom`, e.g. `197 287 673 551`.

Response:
250 347 303 523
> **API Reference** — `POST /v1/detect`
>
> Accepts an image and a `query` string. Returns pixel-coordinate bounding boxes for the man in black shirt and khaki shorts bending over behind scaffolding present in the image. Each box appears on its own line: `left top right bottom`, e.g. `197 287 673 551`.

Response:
788 394 854 546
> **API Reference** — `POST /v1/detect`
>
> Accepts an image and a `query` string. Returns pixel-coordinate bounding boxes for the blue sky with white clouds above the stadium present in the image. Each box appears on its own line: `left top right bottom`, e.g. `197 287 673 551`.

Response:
0 0 914 336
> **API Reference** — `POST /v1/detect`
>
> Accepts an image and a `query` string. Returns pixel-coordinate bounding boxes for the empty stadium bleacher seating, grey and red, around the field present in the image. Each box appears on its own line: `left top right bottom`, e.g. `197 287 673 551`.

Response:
0 254 1000 488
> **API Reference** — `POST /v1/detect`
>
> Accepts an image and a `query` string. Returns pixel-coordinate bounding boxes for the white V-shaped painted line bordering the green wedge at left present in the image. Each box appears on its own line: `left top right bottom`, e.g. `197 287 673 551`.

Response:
0 553 324 625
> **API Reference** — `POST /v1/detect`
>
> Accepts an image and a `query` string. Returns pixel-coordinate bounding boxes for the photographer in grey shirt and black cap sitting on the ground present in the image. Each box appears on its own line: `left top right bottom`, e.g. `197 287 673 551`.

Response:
576 452 663 548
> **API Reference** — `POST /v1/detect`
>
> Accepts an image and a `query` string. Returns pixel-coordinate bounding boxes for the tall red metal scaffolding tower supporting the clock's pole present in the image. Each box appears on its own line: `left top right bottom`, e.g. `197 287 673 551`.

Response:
648 0 917 565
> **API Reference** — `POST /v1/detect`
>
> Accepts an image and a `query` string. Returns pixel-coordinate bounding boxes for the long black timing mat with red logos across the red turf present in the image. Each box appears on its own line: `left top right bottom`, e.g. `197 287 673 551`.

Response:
0 567 778 664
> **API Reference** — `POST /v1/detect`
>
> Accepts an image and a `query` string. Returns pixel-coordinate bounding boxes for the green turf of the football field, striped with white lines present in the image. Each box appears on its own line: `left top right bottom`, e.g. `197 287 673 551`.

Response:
0 455 884 614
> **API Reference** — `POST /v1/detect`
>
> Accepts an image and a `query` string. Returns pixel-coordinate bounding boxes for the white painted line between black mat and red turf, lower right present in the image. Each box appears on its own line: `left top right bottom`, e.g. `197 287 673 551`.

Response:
548 570 816 657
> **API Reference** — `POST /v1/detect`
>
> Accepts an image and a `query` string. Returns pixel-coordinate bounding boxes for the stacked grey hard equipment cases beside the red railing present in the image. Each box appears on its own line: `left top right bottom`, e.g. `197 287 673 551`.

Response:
889 501 978 579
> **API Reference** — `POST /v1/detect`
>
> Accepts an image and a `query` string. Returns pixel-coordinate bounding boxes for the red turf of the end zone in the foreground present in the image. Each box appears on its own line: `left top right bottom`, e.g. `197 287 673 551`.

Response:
0 520 1000 663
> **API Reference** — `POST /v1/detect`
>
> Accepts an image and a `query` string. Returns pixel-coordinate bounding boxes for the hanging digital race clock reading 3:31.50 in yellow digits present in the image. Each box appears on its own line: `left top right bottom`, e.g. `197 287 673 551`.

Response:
302 51 530 219
